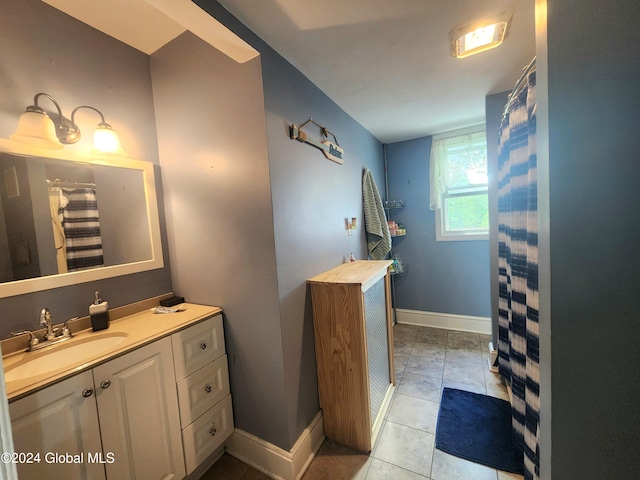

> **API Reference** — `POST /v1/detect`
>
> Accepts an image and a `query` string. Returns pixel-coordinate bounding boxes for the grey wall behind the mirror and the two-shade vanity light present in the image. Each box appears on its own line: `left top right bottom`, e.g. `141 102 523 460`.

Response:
0 0 171 338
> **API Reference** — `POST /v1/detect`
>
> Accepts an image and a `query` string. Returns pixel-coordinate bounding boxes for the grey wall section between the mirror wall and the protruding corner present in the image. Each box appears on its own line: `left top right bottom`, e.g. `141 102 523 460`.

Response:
151 33 288 446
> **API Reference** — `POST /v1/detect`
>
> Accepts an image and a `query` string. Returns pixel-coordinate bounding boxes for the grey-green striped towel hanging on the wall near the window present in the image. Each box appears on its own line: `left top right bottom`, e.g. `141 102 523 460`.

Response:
362 168 391 260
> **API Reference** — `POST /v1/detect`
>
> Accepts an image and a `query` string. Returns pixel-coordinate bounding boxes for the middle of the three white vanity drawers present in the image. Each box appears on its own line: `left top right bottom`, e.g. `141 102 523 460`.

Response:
178 355 230 427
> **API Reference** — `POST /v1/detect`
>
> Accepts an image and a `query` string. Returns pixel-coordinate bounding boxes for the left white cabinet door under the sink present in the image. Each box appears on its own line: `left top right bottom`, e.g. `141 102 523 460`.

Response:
9 372 105 480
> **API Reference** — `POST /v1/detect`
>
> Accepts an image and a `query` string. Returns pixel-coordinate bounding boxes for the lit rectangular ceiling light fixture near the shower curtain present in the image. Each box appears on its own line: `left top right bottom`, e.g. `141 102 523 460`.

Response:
449 12 512 58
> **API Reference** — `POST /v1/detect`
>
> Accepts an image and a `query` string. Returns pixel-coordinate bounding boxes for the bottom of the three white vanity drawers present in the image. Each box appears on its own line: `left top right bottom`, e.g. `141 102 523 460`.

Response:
182 395 233 475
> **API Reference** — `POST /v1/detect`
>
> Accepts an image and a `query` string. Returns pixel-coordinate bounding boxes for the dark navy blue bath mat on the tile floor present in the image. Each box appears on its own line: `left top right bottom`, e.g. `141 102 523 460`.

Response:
436 388 524 473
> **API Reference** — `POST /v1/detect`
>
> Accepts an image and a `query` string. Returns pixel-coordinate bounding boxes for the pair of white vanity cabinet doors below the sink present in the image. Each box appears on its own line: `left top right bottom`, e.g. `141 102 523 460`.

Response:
9 337 185 480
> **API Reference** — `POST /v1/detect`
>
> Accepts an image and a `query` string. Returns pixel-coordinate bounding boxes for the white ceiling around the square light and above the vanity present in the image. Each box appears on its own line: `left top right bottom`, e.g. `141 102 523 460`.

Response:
44 0 535 143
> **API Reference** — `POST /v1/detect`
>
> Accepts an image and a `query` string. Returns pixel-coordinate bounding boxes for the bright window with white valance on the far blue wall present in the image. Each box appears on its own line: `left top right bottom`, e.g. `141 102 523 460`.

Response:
429 126 489 241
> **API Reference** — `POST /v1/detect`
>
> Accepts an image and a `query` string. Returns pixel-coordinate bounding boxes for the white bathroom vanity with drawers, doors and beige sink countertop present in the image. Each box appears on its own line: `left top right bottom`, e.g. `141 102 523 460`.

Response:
3 304 233 480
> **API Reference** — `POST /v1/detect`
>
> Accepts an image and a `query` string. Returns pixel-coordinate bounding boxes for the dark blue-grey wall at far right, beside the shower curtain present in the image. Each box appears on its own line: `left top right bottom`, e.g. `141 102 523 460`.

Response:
537 0 640 480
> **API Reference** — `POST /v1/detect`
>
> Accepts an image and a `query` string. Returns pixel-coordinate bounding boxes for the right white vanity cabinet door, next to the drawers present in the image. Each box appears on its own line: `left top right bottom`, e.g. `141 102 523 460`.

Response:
94 338 185 480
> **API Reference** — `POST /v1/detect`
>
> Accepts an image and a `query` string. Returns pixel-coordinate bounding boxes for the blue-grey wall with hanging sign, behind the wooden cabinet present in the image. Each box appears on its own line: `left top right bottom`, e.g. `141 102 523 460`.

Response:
254 26 384 446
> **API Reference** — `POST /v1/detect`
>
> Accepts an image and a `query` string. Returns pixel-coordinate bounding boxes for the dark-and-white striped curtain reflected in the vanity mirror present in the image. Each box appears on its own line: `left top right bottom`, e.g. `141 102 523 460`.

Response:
62 188 104 272
